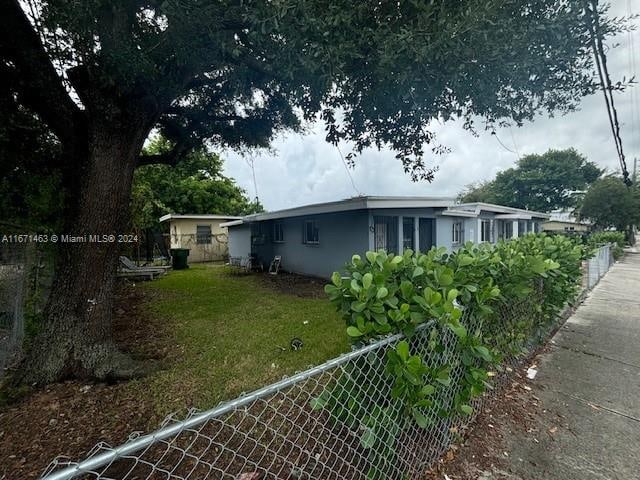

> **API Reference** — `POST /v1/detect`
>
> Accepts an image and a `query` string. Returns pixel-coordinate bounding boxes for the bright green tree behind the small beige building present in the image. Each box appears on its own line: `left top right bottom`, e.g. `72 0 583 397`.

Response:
131 138 264 230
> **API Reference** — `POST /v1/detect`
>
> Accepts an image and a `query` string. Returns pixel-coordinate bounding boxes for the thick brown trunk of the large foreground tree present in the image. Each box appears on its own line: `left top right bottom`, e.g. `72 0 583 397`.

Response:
21 114 148 384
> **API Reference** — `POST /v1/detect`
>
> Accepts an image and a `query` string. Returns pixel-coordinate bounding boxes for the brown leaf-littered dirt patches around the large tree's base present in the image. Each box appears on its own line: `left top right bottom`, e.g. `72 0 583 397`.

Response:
0 285 175 480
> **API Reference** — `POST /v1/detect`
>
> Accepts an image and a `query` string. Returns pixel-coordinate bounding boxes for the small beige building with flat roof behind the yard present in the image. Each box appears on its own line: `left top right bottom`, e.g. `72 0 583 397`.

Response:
160 213 242 263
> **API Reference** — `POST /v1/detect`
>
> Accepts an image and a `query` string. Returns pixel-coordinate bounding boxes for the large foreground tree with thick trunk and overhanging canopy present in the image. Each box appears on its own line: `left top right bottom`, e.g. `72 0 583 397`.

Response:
0 0 620 384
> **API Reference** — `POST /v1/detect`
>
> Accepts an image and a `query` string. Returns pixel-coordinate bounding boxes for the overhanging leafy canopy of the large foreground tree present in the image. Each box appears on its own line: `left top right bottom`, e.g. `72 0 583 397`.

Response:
11 0 621 178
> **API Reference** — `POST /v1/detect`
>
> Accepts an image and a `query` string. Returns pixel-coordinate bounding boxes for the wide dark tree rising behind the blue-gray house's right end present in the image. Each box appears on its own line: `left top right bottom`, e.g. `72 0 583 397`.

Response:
460 148 603 212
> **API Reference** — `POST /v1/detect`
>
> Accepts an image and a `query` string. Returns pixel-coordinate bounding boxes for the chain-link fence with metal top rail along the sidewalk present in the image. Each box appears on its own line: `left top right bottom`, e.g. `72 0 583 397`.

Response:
43 247 610 480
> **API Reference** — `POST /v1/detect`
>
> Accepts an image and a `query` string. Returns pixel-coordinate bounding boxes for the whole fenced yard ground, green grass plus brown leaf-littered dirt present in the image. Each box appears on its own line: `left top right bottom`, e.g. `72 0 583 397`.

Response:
0 265 349 479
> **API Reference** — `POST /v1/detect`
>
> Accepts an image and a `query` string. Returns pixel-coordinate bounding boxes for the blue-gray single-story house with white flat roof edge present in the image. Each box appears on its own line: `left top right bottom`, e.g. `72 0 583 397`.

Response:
221 196 549 278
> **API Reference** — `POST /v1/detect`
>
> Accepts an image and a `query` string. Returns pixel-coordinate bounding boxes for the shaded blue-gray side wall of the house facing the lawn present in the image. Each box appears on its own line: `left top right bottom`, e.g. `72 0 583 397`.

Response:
251 210 369 278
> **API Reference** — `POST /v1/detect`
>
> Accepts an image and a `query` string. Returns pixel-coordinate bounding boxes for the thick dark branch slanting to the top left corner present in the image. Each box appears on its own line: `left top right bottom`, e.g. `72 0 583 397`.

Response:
0 0 82 143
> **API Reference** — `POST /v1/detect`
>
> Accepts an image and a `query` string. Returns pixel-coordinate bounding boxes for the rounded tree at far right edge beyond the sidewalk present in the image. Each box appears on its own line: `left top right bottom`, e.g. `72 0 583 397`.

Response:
579 175 640 232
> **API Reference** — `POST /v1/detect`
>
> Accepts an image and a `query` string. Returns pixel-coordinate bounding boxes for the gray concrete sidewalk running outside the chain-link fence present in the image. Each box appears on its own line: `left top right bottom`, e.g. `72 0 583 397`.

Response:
492 254 640 480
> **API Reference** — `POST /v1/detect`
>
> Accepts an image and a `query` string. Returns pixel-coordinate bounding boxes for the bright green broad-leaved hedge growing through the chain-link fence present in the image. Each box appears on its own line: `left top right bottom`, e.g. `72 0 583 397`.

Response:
322 234 587 478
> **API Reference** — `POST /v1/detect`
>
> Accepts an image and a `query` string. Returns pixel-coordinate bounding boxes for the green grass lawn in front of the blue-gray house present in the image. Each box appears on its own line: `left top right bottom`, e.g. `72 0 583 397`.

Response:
131 265 349 416
